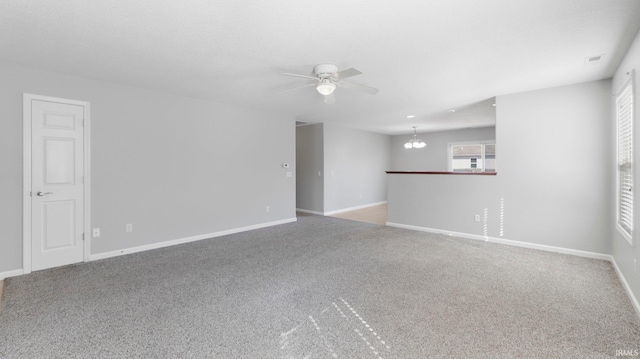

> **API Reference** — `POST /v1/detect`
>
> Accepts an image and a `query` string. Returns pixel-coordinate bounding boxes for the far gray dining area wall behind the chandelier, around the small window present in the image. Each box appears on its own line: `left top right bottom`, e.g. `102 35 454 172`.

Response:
391 127 500 171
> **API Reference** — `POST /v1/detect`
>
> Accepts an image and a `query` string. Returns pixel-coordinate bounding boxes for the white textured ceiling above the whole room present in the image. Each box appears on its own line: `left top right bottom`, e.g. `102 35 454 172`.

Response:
0 0 640 134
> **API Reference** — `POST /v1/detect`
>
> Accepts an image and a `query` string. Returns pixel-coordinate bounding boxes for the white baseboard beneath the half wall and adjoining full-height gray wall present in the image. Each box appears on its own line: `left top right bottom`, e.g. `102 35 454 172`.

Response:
387 222 611 261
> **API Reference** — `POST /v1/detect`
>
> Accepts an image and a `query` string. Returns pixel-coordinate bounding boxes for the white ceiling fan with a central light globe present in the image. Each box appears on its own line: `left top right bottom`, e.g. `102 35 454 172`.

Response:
280 64 378 104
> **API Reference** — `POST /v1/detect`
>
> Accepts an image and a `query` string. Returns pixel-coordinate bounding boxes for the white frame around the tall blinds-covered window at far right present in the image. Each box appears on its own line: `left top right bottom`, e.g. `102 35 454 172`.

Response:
614 72 636 246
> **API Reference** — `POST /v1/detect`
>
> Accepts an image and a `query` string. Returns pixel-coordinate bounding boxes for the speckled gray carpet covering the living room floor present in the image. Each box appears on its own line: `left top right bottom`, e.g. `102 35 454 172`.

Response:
0 216 640 358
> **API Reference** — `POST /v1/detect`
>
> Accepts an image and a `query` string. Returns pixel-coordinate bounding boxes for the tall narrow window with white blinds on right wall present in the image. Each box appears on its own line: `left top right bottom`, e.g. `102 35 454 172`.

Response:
616 76 633 244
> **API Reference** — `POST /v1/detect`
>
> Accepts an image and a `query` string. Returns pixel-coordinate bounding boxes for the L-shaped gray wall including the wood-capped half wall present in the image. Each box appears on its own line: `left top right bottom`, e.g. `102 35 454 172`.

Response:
388 80 613 253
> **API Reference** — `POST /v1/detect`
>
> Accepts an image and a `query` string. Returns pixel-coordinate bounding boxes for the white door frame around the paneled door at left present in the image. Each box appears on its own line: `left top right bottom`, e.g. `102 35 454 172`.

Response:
22 93 91 274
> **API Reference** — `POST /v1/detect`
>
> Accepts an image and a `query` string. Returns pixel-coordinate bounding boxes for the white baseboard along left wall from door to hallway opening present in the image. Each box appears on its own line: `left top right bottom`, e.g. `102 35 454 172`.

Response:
89 217 298 261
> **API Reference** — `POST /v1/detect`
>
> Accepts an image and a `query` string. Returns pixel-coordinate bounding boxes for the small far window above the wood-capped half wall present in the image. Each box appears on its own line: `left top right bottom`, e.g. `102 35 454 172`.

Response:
449 141 496 172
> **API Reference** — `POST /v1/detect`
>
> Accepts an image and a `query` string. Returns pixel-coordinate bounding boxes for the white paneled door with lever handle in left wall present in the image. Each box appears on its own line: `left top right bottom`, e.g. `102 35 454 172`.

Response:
25 99 85 270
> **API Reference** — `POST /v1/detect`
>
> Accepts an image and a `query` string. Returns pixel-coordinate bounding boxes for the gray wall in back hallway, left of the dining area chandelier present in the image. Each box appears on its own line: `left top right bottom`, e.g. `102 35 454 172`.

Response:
324 124 391 212
